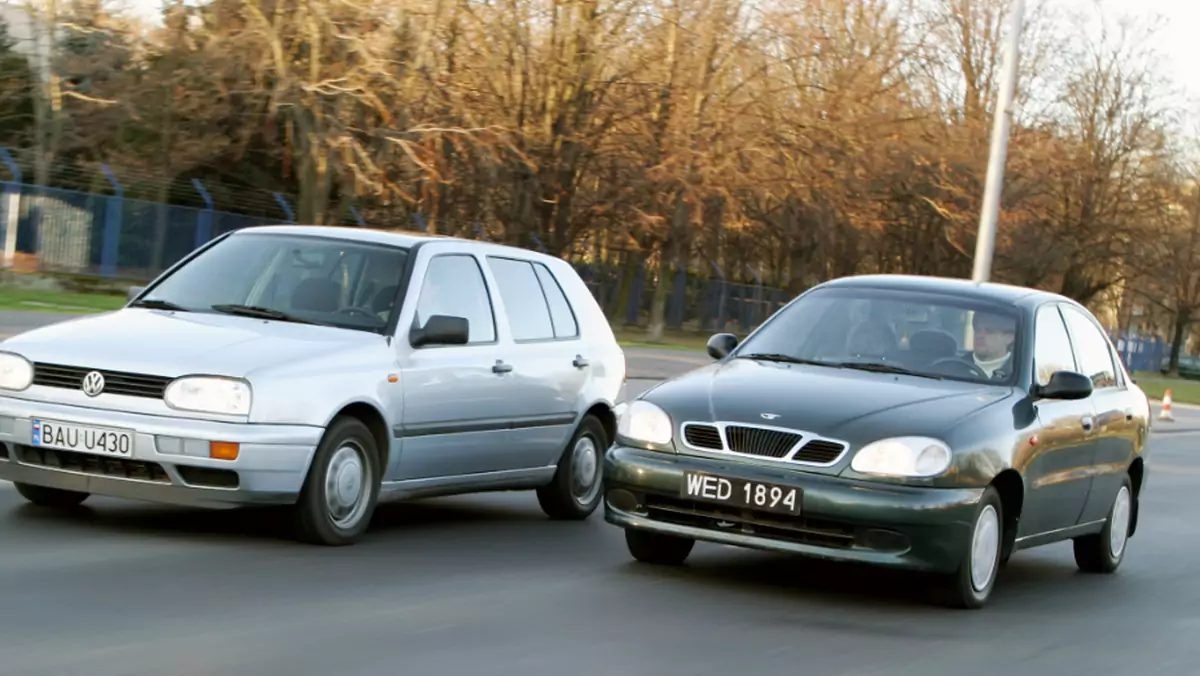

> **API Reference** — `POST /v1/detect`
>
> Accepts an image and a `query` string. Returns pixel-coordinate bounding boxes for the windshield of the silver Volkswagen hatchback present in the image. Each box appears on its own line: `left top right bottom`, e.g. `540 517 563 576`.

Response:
134 233 408 331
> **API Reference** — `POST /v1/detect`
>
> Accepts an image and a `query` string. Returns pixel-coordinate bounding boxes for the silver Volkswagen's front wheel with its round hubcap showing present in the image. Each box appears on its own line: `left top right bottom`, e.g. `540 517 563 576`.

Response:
295 417 380 546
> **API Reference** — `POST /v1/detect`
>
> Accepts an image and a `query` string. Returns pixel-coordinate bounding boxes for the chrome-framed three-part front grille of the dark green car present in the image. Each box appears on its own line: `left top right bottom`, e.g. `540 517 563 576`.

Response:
683 423 848 466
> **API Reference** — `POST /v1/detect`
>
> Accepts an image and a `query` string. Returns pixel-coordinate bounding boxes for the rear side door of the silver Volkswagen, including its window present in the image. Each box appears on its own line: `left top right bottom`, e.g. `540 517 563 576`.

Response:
487 256 588 469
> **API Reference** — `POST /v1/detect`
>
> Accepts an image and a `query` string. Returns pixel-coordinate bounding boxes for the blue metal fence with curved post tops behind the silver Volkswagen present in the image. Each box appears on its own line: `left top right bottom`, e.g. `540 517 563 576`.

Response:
0 162 788 333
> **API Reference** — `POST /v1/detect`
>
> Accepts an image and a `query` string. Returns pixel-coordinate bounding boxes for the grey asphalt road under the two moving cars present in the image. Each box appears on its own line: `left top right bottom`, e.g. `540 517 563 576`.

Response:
0 319 1200 676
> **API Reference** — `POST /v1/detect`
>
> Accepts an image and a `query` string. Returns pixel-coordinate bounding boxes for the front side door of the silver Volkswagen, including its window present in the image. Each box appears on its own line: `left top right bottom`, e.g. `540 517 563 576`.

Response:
392 251 523 480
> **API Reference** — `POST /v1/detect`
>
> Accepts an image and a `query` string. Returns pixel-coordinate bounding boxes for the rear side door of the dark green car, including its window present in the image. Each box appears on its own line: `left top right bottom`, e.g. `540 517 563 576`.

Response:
1062 305 1138 524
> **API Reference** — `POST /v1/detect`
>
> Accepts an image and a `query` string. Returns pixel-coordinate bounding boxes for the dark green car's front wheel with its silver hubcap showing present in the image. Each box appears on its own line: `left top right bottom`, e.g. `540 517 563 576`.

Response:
944 486 1004 610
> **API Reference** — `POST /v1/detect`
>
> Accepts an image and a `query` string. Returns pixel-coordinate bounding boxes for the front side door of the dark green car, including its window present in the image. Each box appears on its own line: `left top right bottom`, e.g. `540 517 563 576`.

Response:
1016 303 1097 537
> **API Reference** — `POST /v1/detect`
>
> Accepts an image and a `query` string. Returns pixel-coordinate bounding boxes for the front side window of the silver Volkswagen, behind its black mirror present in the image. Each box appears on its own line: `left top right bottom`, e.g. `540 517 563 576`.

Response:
416 253 496 343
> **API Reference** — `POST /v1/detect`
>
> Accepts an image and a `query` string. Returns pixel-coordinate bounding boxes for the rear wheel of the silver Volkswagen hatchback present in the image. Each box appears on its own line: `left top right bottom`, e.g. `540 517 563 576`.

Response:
538 413 608 520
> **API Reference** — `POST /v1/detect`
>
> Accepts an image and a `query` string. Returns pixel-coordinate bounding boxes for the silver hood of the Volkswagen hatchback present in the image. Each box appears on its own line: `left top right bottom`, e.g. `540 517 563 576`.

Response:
0 309 383 377
